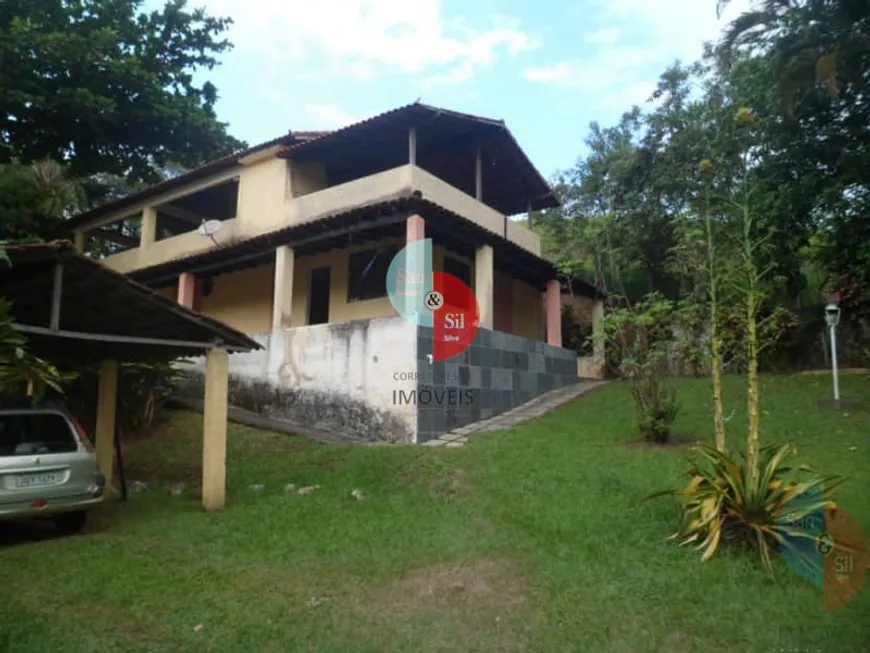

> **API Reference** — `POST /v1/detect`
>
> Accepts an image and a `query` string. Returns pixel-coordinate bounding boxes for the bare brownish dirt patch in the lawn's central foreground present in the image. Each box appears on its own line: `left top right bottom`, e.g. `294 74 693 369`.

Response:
355 559 527 652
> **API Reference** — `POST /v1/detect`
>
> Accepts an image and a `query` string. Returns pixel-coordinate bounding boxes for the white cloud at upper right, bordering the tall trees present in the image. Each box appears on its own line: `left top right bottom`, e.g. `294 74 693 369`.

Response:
523 0 751 101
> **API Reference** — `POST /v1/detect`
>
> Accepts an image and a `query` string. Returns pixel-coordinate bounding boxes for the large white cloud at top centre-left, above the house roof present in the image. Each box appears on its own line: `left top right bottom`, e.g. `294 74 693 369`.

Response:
200 0 538 81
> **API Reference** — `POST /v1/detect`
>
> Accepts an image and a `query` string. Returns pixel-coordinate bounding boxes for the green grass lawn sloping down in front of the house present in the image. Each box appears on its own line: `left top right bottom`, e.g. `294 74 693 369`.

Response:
0 375 870 653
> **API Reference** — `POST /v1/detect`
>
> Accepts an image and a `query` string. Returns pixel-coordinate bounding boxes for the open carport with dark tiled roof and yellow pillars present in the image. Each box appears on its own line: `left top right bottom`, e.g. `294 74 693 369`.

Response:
0 241 260 510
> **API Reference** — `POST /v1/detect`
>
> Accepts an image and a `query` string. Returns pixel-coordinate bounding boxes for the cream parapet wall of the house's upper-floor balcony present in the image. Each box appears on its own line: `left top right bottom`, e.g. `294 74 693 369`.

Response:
88 164 540 273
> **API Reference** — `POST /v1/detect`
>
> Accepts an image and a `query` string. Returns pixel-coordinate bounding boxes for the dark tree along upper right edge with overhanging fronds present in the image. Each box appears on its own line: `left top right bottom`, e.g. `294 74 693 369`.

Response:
718 0 870 297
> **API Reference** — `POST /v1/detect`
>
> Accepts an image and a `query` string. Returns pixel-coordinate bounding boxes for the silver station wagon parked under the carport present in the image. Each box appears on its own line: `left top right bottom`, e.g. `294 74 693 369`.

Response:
0 399 106 535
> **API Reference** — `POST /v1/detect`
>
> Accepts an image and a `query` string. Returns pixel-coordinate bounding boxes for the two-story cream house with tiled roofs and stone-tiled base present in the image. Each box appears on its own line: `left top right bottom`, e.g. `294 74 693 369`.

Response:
64 103 603 442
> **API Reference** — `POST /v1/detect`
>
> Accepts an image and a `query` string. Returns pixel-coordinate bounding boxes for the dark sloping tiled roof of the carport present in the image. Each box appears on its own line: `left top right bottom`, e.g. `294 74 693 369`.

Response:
0 241 261 365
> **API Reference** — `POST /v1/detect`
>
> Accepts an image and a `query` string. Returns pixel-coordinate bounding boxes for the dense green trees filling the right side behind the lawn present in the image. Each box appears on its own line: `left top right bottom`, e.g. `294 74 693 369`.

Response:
534 0 870 331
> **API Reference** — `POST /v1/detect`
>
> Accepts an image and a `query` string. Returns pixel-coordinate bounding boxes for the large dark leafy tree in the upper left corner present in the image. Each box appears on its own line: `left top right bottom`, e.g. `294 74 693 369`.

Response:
0 0 243 182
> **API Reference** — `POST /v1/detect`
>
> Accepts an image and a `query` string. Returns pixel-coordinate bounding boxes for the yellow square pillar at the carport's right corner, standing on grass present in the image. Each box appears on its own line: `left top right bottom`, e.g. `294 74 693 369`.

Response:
202 347 230 510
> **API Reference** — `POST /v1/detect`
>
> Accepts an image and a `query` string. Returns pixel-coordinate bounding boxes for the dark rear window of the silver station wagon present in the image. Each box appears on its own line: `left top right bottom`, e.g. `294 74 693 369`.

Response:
0 412 78 456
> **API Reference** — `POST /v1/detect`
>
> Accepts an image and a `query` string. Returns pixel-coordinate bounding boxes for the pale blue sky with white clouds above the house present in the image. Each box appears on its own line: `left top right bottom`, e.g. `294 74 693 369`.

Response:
155 0 749 177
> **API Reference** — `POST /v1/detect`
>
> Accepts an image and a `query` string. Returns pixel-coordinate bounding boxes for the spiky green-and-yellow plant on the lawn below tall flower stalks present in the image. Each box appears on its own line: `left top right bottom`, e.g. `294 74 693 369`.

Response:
647 445 844 575
